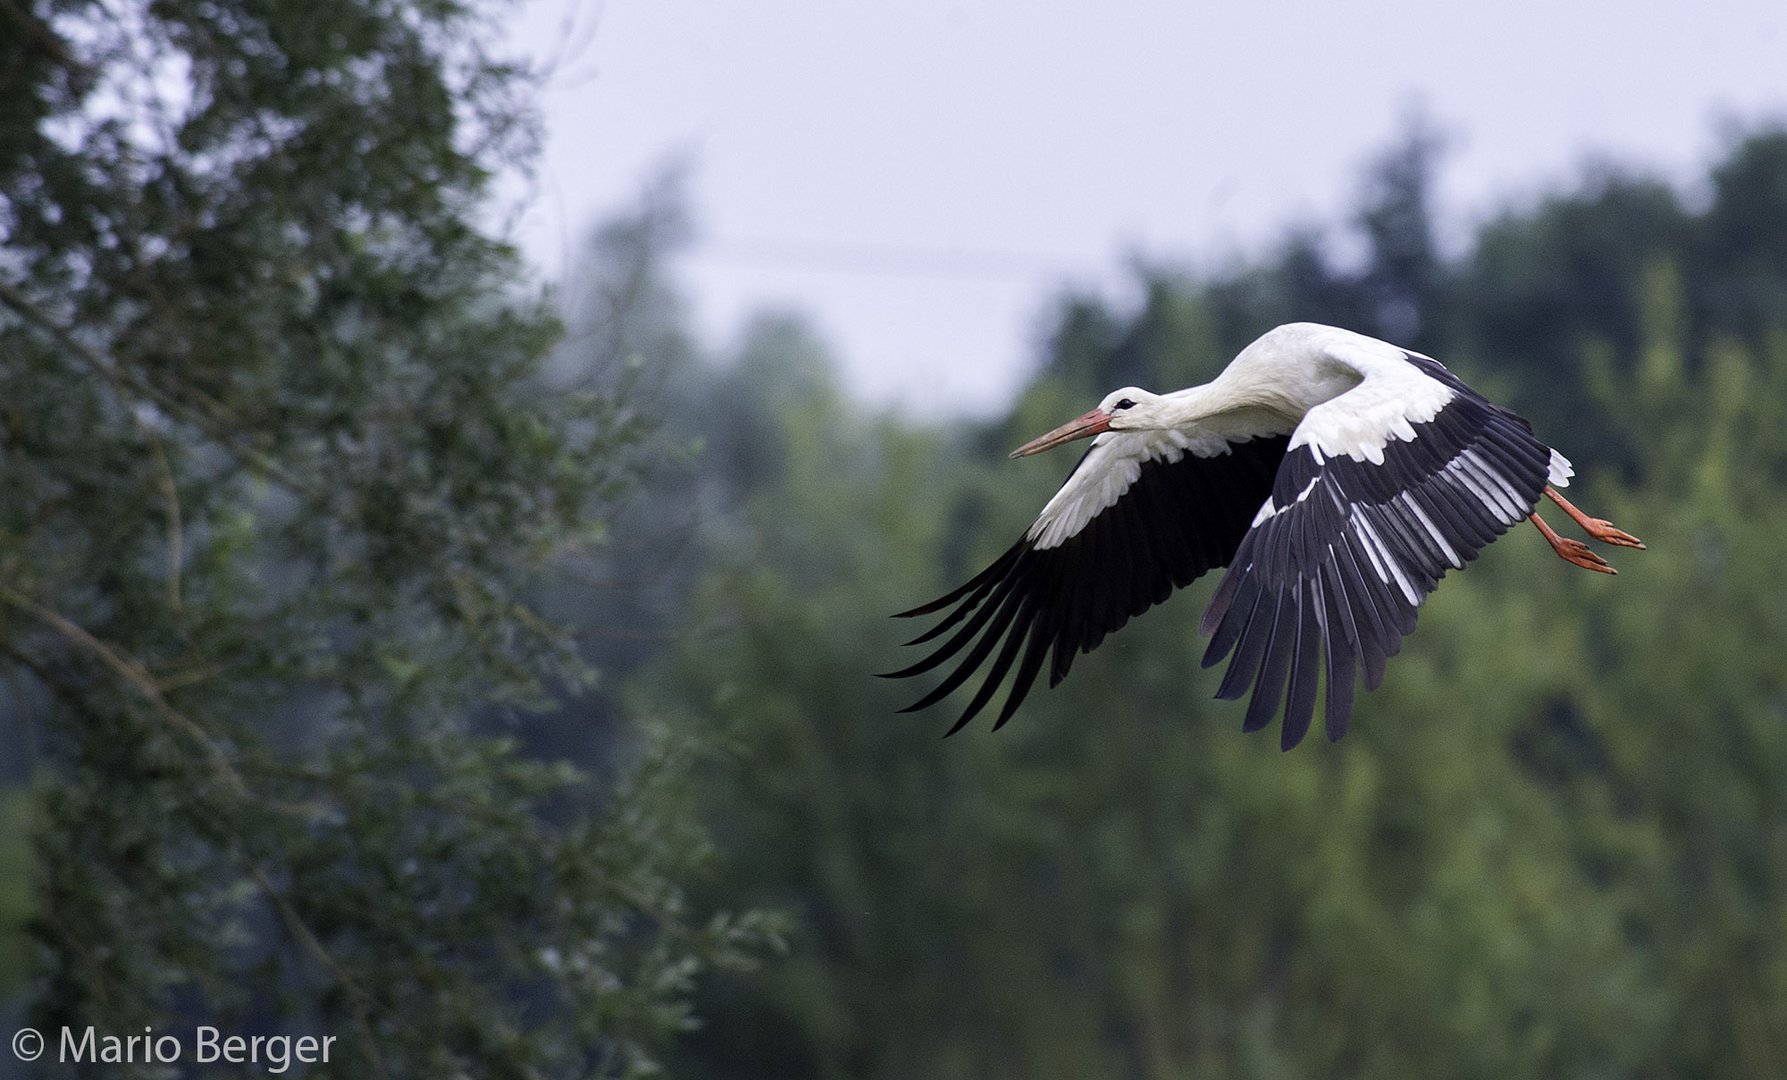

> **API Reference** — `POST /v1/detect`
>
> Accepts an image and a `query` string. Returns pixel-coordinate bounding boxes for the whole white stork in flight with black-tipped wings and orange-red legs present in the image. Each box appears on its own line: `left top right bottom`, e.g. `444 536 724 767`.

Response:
888 322 1644 749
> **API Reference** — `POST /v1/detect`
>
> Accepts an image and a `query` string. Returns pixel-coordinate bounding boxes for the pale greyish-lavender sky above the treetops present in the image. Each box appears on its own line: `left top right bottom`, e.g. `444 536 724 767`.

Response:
516 0 1787 413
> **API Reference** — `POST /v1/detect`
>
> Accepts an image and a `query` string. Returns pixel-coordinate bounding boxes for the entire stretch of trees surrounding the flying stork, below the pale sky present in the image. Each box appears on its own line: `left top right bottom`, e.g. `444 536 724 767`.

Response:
0 0 1787 1080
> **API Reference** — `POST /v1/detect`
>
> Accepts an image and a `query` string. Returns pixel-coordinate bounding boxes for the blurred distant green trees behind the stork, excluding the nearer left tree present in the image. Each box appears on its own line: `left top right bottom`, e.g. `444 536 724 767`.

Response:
647 127 1787 1078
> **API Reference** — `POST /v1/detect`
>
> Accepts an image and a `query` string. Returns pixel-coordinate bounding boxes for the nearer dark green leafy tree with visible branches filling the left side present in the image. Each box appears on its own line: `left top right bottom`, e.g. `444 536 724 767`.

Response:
0 0 758 1076
